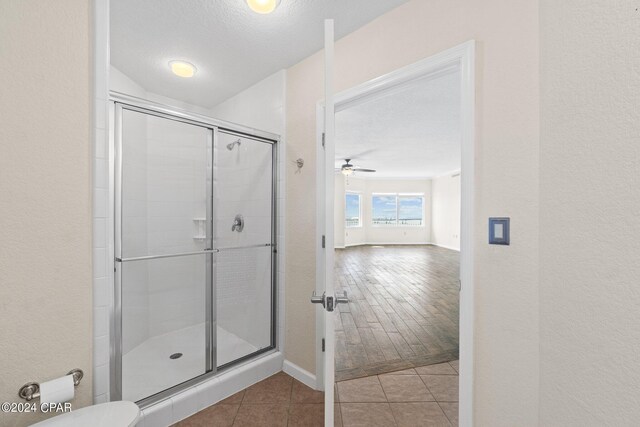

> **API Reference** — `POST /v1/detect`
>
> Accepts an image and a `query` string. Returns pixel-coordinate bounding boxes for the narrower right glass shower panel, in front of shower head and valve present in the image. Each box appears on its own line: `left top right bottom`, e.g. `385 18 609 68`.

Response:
214 131 274 366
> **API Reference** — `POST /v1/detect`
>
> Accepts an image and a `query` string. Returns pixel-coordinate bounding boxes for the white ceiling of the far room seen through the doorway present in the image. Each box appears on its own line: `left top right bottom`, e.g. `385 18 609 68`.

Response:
336 71 461 178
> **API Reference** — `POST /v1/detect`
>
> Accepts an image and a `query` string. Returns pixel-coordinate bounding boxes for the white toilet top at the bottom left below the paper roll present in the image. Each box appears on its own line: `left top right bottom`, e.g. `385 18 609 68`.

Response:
33 401 140 427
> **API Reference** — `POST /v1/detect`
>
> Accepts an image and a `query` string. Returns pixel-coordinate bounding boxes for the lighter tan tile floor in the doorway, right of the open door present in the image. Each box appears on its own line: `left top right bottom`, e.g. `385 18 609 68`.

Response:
336 360 458 427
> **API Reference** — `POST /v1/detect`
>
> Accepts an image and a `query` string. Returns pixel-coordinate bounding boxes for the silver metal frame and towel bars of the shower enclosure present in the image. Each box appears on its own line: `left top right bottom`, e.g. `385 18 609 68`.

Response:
109 91 280 408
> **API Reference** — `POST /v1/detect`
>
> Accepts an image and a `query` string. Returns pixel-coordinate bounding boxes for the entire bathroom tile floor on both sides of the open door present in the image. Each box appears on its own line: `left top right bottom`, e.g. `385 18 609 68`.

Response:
175 361 458 427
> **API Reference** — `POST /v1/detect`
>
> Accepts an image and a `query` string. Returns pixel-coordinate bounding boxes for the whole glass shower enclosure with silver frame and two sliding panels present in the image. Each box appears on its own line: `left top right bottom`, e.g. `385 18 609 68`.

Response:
111 100 277 406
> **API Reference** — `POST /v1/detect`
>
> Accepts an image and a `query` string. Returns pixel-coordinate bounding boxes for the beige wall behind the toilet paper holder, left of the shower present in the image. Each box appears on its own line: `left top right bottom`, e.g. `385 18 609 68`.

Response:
0 0 92 426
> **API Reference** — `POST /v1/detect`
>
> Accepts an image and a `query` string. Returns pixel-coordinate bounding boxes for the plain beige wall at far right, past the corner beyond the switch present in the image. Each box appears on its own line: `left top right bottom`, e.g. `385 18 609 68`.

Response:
540 0 640 426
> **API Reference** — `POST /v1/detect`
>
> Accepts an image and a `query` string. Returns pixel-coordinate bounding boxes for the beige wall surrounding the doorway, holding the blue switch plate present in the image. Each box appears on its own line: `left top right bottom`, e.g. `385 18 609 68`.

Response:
286 0 539 426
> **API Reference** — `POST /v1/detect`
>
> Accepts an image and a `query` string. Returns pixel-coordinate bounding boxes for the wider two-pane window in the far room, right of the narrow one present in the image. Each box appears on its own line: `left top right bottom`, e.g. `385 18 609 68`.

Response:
371 194 424 227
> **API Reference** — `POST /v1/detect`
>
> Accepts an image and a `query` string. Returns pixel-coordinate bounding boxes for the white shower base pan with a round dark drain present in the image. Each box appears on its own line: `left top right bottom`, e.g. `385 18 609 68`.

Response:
122 323 259 402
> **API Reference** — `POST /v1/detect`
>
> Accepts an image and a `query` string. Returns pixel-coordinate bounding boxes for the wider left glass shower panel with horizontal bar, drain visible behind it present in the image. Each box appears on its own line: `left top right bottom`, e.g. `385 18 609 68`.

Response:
116 109 212 401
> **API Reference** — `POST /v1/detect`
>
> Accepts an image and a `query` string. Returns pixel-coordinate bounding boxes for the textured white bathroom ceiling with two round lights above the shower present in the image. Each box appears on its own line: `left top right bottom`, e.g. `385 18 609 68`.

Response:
110 0 407 108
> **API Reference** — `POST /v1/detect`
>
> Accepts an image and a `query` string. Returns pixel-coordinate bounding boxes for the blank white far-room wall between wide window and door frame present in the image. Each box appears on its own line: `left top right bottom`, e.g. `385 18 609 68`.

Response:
431 173 461 251
